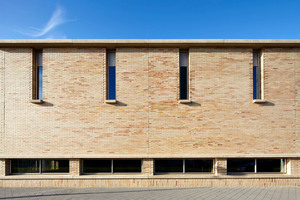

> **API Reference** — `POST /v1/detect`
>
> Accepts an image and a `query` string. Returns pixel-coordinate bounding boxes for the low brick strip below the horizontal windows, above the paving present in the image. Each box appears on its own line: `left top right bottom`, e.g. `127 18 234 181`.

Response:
0 177 300 187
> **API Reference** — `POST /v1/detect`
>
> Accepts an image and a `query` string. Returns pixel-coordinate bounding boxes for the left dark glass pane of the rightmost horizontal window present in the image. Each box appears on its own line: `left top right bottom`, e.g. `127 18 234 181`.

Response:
227 159 255 172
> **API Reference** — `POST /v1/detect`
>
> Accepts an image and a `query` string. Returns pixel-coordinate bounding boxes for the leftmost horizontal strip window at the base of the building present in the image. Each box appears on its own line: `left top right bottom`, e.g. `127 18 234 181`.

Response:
10 159 69 174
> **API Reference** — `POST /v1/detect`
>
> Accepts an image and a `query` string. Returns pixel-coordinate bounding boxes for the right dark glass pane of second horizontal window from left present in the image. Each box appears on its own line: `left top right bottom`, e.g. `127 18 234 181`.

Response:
113 160 142 173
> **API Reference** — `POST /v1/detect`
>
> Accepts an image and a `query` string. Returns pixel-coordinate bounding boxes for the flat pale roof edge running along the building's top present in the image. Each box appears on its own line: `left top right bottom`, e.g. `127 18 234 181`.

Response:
0 39 300 48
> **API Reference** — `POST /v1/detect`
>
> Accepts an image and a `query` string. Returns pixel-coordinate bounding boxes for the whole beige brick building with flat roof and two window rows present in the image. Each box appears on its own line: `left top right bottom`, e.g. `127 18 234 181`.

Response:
0 40 300 187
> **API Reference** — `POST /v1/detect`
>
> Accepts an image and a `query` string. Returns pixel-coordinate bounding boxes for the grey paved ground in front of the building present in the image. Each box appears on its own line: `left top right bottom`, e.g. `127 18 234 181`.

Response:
0 187 300 200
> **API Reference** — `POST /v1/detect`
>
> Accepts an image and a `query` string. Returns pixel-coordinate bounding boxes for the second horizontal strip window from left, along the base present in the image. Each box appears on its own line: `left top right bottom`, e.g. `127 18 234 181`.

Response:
82 159 142 174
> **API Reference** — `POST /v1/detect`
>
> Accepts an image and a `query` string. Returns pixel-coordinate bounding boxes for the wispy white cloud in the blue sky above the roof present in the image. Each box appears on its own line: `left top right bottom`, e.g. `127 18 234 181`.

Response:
18 6 70 38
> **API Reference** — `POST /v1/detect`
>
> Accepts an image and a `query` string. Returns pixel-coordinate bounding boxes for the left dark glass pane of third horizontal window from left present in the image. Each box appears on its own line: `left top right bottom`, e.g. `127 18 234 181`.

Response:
155 160 183 172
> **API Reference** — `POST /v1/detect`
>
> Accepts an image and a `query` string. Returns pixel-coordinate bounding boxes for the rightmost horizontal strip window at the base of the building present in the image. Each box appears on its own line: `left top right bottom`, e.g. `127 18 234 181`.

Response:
227 158 286 173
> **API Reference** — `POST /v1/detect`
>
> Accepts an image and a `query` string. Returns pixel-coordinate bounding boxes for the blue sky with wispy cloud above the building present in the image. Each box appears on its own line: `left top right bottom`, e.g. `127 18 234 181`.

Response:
0 0 300 39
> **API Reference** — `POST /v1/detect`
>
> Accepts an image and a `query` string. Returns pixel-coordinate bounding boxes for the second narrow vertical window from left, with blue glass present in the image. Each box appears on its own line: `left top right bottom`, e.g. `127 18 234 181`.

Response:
107 50 116 100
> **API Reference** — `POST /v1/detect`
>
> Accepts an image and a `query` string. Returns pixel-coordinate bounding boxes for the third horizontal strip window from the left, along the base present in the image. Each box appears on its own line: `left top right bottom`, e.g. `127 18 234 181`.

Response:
154 159 214 173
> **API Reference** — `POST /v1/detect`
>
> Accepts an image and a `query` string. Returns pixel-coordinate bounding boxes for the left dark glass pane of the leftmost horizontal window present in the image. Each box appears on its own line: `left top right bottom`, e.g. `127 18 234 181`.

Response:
11 160 40 173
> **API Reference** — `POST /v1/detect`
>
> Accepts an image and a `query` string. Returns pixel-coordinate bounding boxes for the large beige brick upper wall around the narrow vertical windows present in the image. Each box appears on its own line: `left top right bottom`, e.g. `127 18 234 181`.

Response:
0 48 300 158
